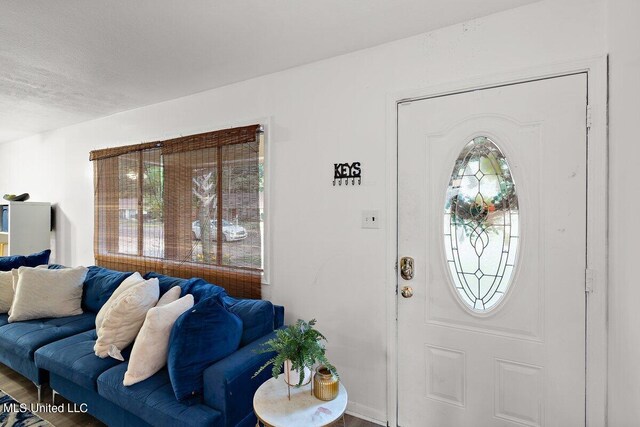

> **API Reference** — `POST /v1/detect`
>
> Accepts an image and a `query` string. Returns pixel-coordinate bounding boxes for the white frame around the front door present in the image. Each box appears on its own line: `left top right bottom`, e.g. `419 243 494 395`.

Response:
385 56 609 427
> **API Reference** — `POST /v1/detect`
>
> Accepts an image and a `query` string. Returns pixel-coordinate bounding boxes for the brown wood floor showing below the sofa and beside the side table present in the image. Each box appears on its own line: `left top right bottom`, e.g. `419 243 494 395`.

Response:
0 365 377 427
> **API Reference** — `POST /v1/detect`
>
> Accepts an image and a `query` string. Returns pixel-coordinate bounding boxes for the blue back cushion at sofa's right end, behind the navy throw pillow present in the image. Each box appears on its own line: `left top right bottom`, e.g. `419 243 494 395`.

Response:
222 296 274 347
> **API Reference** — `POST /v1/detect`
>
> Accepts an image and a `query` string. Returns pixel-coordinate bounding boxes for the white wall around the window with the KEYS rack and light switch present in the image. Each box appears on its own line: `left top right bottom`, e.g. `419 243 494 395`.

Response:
0 0 604 420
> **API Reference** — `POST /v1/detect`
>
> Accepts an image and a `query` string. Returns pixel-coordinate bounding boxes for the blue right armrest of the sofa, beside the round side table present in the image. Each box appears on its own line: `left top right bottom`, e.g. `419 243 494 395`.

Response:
203 332 275 427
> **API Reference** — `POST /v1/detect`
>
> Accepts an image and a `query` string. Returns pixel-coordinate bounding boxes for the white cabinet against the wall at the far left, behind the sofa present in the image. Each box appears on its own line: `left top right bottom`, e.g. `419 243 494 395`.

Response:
0 202 51 256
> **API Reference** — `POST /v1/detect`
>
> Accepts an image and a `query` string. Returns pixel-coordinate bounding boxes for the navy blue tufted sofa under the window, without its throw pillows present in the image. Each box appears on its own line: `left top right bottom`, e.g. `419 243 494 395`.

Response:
0 266 284 426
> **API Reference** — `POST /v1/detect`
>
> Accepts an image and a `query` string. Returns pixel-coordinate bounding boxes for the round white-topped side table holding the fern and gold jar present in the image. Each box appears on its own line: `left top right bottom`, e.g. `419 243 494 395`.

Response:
253 377 348 427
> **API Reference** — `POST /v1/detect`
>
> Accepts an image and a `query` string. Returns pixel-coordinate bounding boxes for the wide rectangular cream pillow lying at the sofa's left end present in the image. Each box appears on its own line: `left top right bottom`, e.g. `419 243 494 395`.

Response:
9 267 87 323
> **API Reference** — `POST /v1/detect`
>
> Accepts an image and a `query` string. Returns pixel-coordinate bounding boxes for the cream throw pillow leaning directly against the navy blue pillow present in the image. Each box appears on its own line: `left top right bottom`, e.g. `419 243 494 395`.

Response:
122 291 193 386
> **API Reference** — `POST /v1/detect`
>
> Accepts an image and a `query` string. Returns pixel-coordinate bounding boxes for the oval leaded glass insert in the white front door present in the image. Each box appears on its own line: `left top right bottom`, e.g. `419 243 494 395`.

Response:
444 136 520 313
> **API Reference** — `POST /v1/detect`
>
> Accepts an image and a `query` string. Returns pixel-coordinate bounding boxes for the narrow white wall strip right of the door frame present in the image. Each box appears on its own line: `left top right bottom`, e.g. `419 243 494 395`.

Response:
607 0 640 427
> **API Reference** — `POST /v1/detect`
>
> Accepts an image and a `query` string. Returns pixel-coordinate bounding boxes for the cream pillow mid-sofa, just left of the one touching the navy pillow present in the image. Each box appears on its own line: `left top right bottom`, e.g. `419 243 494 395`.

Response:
93 278 160 360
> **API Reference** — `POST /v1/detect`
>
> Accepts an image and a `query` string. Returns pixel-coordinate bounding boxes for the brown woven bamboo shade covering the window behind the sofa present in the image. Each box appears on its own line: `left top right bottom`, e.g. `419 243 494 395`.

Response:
90 125 264 298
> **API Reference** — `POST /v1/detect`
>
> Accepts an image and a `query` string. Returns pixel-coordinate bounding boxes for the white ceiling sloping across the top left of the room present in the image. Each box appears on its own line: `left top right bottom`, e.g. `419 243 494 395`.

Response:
0 0 537 142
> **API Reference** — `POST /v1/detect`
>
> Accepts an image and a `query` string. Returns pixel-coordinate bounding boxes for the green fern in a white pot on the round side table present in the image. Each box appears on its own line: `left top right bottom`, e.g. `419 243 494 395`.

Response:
253 319 338 387
